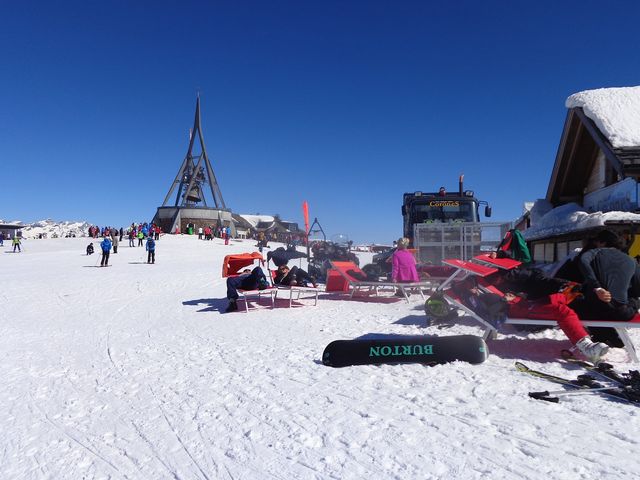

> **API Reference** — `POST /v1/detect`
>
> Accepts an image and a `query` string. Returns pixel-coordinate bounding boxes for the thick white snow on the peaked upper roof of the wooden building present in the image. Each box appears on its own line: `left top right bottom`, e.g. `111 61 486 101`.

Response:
565 86 640 148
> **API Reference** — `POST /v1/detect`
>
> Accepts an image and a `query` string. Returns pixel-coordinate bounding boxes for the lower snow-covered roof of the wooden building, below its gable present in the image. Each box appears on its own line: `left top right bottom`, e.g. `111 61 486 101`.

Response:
522 202 640 240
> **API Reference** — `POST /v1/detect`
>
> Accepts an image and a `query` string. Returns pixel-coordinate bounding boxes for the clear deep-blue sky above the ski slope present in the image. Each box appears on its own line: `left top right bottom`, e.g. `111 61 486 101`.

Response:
0 0 640 243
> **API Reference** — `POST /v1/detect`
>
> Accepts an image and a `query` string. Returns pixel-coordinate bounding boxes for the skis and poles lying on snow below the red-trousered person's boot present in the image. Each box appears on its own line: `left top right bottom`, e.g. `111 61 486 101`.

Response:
516 356 640 404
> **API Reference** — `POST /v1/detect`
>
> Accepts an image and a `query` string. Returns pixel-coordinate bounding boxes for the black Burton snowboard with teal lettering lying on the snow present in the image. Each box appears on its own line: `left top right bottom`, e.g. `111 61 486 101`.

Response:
322 335 489 367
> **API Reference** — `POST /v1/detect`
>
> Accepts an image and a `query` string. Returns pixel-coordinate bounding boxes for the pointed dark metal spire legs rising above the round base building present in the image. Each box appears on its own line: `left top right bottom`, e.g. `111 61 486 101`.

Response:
162 95 227 209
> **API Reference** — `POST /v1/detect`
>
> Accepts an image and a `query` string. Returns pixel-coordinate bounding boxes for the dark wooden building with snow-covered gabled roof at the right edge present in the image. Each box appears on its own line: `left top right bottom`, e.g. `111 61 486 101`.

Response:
521 87 640 262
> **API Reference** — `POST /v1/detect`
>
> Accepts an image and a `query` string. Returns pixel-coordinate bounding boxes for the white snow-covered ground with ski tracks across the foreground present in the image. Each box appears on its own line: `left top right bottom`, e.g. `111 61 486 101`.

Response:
0 236 640 480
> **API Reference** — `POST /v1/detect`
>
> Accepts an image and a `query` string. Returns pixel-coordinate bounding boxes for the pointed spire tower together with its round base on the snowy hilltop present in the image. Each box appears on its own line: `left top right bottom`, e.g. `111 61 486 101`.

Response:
153 94 235 234
